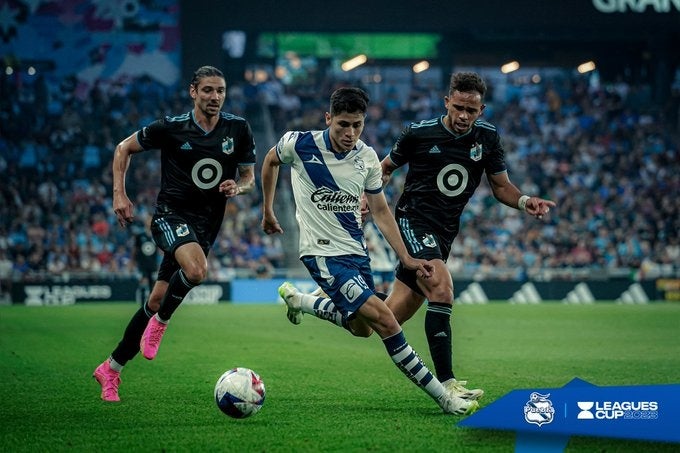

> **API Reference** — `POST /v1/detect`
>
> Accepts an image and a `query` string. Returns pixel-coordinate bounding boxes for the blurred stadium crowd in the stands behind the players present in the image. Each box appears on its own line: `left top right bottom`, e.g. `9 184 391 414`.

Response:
0 65 680 290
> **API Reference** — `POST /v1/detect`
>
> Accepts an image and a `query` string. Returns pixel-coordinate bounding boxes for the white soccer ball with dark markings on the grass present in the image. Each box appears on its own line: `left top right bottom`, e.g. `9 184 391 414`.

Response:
215 367 265 418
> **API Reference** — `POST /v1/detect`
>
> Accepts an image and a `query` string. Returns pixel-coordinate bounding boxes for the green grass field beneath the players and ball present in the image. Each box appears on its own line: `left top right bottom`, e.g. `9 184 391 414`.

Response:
0 303 680 453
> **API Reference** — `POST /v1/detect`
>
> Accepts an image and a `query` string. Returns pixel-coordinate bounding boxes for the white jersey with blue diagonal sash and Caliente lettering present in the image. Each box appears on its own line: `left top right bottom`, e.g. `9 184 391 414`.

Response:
276 129 382 257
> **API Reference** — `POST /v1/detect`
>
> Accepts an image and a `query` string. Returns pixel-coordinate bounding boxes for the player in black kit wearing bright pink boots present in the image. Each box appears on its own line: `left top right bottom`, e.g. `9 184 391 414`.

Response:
93 66 255 401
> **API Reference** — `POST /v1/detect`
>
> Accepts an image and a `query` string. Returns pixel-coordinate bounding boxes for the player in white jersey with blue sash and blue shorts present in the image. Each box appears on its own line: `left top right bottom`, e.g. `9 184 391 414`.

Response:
262 87 479 414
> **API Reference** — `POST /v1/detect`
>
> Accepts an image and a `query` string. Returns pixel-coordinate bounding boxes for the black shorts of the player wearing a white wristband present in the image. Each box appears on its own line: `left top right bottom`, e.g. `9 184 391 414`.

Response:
396 215 455 296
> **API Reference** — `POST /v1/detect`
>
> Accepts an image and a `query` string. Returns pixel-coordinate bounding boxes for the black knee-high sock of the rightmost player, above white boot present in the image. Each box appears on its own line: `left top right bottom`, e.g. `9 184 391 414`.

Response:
425 302 454 382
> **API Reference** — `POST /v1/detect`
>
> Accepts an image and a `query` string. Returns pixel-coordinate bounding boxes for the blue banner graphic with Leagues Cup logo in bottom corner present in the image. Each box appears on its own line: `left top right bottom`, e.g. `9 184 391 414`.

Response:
458 378 680 452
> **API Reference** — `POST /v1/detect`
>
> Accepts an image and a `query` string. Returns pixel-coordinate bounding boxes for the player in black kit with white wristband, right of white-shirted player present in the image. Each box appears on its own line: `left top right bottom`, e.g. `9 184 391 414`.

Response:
381 72 555 399
